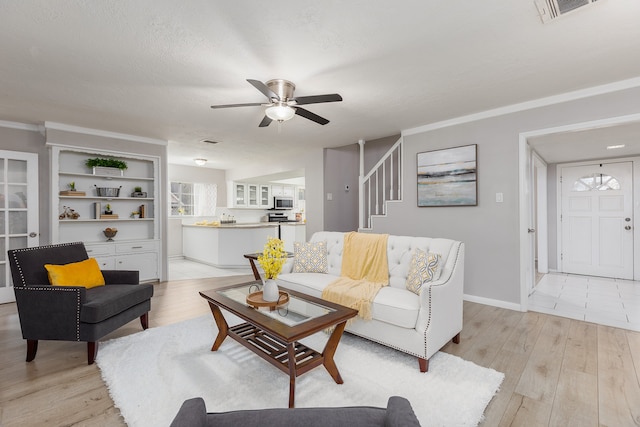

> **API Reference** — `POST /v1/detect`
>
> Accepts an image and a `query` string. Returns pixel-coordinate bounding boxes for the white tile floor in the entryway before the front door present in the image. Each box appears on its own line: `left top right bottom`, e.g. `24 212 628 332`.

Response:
529 273 640 331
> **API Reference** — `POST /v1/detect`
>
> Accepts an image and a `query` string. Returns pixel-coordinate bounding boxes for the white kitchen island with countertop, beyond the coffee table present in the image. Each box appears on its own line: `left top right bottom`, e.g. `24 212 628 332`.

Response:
182 222 278 268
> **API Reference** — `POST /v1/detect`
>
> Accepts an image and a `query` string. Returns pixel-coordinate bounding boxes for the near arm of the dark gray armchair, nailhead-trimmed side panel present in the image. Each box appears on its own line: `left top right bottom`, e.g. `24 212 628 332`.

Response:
14 285 87 341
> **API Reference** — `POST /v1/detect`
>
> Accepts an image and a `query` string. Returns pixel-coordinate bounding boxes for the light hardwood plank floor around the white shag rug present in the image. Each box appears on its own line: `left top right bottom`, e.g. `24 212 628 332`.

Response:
0 276 640 427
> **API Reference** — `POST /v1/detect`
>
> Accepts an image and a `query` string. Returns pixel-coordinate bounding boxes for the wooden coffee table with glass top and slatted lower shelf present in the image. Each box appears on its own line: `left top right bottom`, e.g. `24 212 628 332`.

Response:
200 281 358 408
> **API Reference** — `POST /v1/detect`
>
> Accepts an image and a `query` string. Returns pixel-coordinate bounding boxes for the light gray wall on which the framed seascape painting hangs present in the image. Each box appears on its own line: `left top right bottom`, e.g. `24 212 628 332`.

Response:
374 88 640 305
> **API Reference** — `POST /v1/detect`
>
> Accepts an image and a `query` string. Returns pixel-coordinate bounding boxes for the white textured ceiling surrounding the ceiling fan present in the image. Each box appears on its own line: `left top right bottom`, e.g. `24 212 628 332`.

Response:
0 0 640 169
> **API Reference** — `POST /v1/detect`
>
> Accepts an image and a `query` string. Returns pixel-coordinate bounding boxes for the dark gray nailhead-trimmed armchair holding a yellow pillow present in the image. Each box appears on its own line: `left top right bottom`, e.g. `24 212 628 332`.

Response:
8 242 153 365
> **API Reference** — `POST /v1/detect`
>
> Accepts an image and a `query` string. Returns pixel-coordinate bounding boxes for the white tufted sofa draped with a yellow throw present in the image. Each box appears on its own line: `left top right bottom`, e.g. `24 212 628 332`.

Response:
278 231 464 372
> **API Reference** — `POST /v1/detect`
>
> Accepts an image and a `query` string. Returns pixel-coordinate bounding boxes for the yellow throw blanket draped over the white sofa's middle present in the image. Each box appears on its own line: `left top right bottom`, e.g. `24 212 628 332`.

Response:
322 232 389 320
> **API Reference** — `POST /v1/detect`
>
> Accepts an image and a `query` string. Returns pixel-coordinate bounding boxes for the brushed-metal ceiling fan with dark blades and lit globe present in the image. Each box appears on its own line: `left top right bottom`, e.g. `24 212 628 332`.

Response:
211 79 342 127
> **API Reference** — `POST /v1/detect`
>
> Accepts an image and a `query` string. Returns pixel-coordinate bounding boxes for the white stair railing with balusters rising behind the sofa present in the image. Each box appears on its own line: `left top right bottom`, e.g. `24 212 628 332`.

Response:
358 137 403 230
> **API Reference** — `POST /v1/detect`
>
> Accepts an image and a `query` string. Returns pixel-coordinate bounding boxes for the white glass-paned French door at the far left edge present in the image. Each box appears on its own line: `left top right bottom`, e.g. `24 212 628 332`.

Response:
0 150 40 303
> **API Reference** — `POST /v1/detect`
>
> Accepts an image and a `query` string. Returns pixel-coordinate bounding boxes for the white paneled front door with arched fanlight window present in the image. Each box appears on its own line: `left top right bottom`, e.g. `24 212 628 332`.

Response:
561 162 633 280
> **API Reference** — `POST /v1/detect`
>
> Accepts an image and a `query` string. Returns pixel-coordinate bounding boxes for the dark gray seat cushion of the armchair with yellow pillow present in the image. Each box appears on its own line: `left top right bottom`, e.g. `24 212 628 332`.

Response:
80 284 153 323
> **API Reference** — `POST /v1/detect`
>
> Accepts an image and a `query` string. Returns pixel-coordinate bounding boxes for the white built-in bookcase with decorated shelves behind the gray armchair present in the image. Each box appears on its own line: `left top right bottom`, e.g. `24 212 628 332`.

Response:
48 144 162 280
